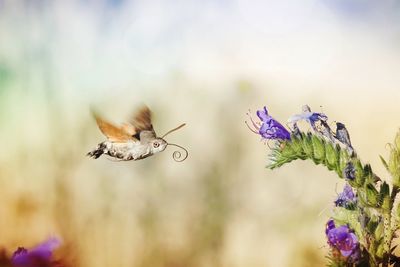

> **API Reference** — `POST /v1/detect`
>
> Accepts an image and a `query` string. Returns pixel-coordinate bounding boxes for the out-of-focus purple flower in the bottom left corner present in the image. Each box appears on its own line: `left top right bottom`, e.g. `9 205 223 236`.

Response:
11 238 61 267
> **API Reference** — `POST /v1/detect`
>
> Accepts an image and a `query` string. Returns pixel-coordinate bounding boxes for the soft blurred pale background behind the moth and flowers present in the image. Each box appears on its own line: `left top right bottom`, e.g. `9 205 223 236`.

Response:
0 0 400 267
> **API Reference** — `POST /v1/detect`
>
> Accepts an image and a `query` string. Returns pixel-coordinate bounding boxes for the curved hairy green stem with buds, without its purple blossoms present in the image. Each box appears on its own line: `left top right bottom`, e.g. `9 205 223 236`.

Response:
267 133 390 266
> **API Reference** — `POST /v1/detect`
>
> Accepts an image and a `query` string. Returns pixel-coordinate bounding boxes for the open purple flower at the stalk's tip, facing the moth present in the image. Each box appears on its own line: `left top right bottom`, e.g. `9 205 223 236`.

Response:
246 107 290 140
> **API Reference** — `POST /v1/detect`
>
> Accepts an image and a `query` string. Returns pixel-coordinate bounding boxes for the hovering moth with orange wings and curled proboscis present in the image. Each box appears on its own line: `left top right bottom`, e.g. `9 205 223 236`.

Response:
87 106 189 162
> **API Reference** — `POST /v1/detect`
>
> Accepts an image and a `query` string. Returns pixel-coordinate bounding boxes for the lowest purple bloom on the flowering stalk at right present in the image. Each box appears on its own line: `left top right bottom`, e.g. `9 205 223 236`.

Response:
325 220 359 262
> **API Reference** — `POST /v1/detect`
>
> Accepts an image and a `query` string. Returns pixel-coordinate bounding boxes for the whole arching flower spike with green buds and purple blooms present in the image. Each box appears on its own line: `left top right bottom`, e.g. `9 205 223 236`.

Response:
252 106 400 266
